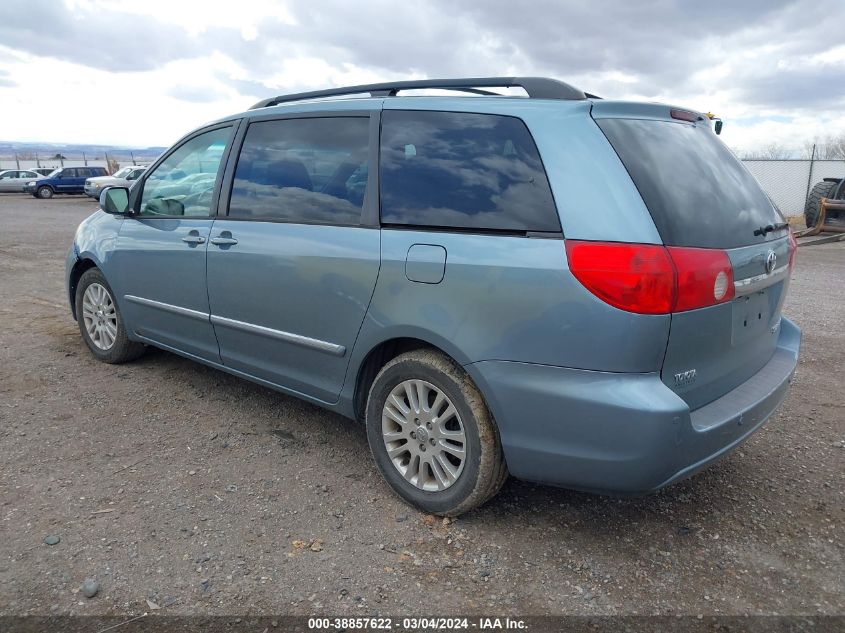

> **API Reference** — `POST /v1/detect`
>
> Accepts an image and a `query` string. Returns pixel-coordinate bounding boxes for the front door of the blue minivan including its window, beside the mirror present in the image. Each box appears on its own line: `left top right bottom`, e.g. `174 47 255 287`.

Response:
109 126 232 362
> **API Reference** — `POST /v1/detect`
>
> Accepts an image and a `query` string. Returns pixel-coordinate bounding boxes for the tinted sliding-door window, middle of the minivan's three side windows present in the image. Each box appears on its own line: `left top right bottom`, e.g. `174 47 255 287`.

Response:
229 117 369 224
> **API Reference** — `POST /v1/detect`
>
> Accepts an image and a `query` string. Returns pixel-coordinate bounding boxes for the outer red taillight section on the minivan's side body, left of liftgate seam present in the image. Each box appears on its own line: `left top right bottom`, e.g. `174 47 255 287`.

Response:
566 240 675 314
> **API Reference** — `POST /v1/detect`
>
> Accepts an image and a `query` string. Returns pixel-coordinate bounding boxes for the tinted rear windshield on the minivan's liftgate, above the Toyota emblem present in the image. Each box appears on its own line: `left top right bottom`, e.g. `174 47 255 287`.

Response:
597 119 783 248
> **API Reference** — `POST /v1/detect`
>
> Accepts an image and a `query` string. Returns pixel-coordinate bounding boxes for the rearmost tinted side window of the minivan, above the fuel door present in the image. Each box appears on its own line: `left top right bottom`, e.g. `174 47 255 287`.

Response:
380 110 560 232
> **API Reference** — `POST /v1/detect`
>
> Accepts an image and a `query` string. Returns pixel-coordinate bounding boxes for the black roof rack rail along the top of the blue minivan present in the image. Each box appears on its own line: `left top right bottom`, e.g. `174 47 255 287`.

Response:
250 77 597 110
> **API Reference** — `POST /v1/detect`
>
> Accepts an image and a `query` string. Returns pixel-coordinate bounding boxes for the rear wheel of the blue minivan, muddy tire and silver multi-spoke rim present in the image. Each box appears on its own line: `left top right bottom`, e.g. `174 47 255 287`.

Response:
366 350 508 516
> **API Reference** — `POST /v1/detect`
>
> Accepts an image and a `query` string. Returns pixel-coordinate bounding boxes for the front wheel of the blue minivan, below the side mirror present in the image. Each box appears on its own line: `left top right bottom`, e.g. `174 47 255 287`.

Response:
75 268 144 364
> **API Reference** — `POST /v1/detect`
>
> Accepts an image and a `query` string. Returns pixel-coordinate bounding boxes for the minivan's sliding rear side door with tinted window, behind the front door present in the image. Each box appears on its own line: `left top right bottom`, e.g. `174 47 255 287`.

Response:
208 115 380 402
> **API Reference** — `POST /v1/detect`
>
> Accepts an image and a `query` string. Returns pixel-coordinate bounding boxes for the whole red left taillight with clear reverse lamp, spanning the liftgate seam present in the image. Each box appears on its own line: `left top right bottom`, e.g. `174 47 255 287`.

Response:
566 240 734 314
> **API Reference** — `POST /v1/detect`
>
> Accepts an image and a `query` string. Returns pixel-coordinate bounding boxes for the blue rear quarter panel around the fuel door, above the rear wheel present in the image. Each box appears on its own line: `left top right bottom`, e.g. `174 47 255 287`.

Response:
352 229 669 372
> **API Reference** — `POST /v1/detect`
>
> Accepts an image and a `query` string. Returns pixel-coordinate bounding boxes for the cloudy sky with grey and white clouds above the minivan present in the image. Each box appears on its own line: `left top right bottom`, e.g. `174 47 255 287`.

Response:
0 0 845 150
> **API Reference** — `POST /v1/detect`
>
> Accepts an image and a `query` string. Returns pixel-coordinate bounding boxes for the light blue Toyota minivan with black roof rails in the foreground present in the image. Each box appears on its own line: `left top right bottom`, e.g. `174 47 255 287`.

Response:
67 77 800 515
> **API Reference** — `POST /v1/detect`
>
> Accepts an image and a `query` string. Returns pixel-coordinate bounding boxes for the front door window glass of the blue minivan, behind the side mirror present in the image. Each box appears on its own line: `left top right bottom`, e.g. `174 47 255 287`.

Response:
139 127 232 217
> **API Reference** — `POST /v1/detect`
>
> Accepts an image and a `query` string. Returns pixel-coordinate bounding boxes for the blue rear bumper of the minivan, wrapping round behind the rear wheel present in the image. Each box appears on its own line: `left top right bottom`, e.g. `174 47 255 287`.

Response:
467 318 801 494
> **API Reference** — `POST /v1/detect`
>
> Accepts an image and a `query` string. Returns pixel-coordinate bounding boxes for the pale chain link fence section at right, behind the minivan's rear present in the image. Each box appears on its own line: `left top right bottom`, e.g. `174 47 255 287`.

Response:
742 159 845 217
